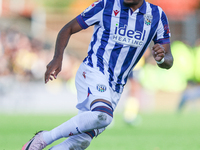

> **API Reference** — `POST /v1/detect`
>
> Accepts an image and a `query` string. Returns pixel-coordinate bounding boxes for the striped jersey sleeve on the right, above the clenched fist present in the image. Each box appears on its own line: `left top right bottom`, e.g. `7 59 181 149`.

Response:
153 11 171 44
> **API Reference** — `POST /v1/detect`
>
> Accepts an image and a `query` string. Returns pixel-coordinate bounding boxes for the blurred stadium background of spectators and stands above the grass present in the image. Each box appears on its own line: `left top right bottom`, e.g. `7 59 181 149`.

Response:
0 0 200 116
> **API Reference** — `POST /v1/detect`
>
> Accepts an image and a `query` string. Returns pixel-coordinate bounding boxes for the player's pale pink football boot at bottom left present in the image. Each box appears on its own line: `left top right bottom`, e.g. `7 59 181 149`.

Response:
22 131 47 150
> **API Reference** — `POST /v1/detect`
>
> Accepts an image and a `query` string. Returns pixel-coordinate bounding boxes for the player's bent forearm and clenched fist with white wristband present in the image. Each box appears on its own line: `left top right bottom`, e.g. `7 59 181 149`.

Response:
152 43 173 69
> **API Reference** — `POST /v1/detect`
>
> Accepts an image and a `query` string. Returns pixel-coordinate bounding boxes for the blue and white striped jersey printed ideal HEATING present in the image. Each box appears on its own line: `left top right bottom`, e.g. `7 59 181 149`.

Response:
76 0 170 93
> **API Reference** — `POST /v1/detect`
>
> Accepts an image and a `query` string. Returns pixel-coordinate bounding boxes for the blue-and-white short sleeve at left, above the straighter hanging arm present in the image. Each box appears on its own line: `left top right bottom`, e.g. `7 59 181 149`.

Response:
76 0 104 29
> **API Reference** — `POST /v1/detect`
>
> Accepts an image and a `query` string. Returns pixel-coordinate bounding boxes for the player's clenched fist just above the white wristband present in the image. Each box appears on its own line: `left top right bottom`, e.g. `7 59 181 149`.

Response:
152 44 165 62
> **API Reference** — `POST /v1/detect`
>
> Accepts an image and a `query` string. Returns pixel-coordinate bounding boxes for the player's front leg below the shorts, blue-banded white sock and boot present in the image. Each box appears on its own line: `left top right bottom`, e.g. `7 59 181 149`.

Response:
23 100 113 150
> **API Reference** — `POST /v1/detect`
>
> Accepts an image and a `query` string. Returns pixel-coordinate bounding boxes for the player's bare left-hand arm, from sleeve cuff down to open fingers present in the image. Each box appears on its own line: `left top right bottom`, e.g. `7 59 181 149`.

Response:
45 18 82 83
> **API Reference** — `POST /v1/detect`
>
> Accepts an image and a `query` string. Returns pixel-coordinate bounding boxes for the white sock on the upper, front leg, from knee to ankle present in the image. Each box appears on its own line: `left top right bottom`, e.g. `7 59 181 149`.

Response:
43 111 112 145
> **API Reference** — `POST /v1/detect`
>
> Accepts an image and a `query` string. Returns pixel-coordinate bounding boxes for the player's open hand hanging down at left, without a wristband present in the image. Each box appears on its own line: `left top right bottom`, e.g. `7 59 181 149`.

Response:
45 58 62 83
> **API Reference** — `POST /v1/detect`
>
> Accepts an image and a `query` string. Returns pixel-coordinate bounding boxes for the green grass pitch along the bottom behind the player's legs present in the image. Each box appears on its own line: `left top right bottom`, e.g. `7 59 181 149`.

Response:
0 113 200 150
